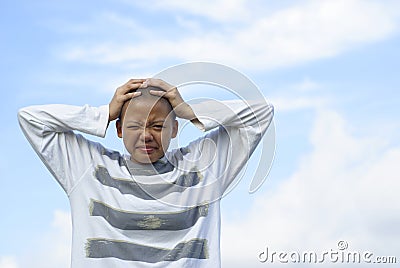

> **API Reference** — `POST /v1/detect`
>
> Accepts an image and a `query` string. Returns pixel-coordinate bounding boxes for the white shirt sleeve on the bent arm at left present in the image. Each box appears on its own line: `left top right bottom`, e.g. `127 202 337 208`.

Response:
18 104 109 194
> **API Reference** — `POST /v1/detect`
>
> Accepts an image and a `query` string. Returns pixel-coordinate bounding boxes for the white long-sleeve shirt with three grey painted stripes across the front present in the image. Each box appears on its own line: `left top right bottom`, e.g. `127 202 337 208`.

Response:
18 101 273 268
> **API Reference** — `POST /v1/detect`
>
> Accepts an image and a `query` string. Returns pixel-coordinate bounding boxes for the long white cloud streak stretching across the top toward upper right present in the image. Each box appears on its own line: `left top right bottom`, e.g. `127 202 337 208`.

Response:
62 0 399 69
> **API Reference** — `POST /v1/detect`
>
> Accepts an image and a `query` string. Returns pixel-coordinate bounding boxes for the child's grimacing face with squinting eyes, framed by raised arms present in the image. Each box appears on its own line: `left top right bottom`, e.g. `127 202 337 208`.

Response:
117 98 178 164
